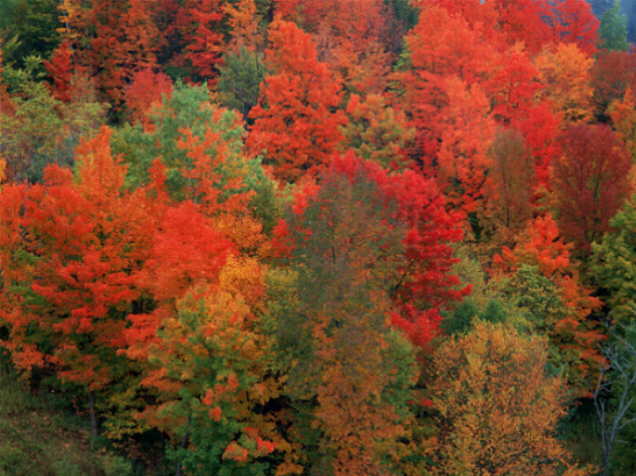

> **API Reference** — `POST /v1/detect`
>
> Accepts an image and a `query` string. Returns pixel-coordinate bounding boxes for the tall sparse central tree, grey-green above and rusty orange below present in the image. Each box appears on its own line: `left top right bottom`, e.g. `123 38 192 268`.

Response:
268 154 415 476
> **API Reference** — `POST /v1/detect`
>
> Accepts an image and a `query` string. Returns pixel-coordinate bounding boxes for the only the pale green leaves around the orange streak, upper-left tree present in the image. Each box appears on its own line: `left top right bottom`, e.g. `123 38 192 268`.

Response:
112 83 279 230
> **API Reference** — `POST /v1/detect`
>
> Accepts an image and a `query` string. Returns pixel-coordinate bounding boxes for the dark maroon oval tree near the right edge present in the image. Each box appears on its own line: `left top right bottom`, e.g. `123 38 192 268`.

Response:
552 125 631 254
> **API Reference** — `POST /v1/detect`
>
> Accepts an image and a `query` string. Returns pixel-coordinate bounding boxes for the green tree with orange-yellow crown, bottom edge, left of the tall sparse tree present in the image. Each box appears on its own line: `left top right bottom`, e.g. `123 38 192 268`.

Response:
151 291 280 476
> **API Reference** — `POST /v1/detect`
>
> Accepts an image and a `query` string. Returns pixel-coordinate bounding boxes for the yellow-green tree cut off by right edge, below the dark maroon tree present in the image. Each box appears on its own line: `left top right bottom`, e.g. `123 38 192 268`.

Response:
590 196 636 324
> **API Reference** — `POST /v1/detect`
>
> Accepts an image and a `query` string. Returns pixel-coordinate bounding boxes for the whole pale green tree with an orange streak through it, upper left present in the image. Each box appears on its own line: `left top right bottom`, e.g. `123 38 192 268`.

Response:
112 83 277 245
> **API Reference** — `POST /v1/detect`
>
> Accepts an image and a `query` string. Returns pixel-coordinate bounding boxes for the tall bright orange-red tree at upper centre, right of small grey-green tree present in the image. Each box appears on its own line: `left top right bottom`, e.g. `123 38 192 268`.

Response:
247 20 344 182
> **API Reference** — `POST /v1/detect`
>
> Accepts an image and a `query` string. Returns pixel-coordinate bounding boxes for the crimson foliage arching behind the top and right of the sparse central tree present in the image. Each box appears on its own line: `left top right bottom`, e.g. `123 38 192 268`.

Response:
284 152 470 345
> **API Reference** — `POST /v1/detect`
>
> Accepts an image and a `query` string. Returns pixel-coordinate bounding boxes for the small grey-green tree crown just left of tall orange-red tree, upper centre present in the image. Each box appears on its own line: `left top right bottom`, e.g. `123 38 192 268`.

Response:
217 47 265 118
